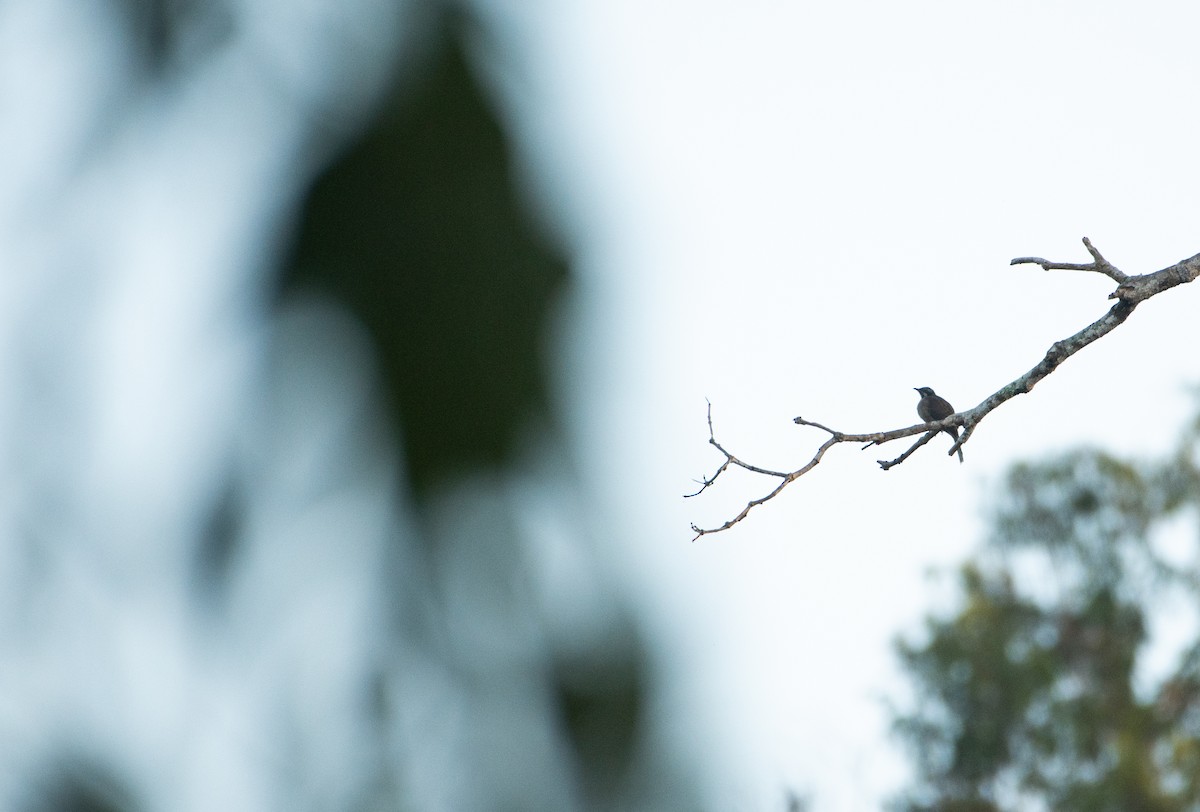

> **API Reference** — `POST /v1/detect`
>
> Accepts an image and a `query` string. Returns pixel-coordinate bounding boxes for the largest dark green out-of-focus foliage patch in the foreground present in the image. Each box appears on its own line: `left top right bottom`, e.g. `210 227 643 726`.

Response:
281 9 568 499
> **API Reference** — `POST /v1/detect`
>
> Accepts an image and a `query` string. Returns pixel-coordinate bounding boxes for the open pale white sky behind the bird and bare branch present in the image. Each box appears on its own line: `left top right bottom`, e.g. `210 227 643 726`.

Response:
477 0 1200 812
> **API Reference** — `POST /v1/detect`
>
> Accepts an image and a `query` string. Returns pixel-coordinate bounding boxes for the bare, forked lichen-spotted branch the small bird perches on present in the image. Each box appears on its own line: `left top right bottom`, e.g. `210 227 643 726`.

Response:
686 236 1200 541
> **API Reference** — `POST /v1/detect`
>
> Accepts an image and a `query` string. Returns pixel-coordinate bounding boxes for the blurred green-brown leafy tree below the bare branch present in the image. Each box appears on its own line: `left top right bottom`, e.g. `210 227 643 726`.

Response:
896 400 1200 812
